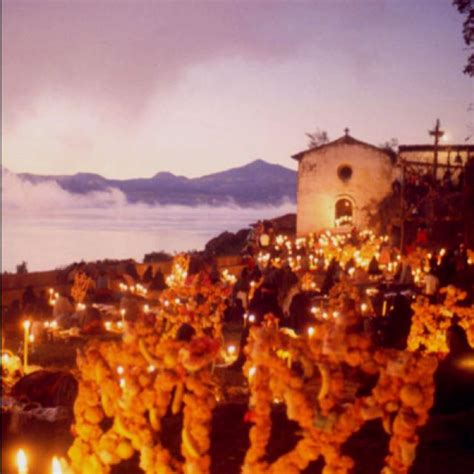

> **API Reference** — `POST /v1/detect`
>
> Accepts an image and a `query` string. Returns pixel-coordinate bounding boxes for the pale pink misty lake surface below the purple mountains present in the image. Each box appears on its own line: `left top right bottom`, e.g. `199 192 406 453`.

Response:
2 172 295 272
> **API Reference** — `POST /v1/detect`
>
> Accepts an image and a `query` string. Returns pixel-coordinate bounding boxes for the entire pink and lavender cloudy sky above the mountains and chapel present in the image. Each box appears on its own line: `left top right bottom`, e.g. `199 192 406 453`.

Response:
2 0 474 178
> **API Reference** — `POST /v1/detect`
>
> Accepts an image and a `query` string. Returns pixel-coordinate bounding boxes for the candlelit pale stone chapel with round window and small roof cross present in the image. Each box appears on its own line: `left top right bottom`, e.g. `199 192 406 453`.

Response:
292 129 396 235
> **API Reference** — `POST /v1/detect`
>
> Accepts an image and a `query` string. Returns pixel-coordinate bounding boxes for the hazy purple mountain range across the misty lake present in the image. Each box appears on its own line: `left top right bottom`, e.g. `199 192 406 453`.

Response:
12 160 296 207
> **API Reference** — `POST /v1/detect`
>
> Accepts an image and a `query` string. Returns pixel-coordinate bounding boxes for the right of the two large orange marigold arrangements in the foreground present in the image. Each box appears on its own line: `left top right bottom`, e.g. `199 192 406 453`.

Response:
242 291 437 474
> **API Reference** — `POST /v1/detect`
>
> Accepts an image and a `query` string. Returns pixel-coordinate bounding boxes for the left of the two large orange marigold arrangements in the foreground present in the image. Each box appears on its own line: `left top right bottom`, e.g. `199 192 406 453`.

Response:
68 325 220 474
